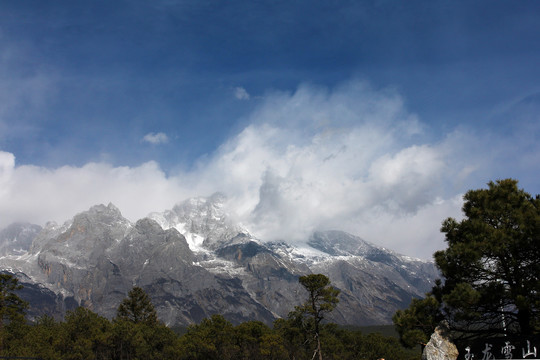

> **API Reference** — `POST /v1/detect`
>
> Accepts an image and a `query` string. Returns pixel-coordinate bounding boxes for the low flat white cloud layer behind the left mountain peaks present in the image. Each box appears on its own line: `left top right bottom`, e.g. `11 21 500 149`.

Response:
0 158 192 228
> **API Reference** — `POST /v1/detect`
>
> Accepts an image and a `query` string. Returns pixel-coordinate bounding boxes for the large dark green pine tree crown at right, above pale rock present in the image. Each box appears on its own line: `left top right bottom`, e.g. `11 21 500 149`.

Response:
394 179 540 345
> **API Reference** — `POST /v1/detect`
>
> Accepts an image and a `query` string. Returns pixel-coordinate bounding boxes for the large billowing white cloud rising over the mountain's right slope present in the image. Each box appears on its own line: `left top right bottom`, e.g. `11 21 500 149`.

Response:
181 83 468 257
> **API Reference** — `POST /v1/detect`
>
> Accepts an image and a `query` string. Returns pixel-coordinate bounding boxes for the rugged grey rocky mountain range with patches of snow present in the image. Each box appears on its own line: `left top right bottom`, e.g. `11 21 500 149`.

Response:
0 194 437 325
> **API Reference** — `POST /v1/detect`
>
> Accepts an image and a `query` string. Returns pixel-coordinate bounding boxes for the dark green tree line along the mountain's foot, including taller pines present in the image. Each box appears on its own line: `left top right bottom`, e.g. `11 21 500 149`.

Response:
0 274 417 360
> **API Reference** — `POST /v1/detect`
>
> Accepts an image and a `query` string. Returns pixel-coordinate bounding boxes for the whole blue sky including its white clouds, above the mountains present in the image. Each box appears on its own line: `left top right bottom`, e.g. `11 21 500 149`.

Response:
0 0 540 258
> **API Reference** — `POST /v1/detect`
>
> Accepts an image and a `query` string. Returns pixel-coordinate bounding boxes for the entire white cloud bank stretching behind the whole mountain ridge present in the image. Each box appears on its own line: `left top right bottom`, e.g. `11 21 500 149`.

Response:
0 82 532 258
